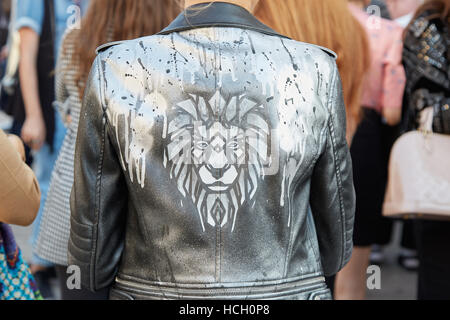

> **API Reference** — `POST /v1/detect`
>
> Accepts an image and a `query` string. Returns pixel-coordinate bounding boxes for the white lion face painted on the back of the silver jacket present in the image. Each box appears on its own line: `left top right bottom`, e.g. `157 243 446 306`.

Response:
164 91 270 231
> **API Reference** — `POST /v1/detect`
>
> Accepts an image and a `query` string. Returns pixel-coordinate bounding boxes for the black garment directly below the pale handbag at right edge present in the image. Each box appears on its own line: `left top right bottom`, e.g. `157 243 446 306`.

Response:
415 221 450 300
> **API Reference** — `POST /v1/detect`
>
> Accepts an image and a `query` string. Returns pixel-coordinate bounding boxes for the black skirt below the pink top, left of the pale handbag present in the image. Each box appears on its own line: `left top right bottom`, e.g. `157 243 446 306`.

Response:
350 108 395 247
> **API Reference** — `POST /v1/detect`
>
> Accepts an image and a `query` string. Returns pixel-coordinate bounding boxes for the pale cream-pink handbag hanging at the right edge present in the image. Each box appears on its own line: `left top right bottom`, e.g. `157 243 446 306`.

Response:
383 107 450 220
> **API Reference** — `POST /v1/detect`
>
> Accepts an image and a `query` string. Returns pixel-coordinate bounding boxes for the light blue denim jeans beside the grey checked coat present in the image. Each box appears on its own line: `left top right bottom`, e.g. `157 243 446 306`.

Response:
30 111 66 266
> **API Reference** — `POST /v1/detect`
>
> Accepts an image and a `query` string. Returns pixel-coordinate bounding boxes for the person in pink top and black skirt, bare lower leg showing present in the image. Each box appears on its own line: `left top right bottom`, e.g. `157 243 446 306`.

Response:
335 0 405 299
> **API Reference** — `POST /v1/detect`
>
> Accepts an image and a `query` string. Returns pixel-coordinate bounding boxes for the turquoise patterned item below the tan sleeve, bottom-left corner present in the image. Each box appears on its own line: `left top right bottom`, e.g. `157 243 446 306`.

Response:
0 222 42 300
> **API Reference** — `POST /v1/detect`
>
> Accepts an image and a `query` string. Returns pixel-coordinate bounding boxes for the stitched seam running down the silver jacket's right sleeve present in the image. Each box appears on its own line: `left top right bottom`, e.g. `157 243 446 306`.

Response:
328 67 347 269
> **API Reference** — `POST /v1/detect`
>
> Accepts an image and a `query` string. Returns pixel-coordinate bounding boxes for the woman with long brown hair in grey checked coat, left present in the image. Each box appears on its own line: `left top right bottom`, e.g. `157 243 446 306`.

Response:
36 0 180 300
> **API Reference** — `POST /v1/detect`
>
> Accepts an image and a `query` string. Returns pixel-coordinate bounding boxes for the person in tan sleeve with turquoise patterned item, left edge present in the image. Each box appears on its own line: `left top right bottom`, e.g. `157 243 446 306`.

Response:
0 130 42 300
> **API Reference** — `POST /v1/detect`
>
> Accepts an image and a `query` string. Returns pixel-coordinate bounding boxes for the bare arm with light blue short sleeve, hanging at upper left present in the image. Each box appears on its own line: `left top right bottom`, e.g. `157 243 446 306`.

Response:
15 0 46 150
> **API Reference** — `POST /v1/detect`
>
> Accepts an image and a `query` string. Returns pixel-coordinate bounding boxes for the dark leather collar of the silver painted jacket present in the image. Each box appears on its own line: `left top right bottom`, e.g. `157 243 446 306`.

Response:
158 1 289 39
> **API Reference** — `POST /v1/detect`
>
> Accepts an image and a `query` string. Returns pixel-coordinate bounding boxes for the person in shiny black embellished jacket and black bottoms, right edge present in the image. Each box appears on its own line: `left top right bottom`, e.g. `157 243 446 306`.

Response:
403 0 450 300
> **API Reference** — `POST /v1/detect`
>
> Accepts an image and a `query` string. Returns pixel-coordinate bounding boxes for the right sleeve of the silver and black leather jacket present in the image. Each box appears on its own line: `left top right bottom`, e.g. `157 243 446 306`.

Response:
310 64 355 276
